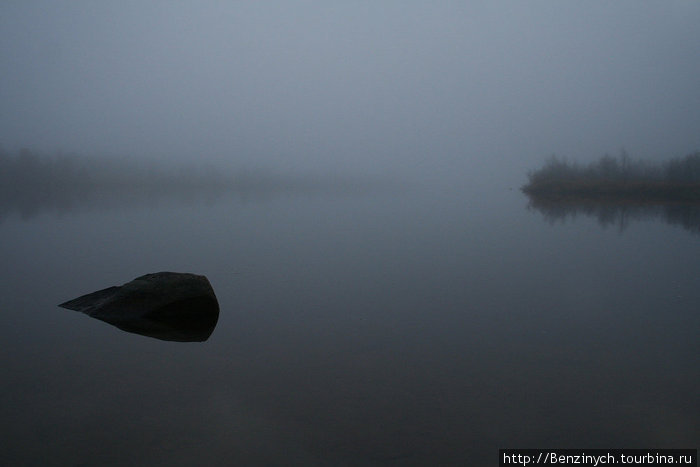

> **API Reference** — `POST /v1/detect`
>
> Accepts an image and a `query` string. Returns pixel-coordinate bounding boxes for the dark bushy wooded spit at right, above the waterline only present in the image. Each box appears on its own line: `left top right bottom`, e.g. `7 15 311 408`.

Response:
522 151 700 200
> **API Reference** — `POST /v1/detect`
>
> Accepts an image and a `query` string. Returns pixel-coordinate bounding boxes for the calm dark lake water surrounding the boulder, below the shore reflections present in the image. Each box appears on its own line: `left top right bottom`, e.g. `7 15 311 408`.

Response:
0 182 700 466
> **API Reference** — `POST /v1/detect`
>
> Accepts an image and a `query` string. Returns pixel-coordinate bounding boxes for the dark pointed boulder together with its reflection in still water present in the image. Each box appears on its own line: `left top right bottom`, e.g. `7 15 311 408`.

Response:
58 272 219 342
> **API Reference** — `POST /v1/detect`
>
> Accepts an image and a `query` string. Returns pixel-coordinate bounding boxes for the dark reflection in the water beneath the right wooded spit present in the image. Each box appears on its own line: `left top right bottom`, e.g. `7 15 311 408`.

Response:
528 196 700 235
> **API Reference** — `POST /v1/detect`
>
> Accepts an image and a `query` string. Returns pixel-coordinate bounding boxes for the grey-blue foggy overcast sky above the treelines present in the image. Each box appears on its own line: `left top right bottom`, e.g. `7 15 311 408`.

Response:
0 0 700 181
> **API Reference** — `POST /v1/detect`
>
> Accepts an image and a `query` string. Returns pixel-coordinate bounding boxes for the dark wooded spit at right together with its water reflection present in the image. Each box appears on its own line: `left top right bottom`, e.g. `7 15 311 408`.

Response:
522 151 700 234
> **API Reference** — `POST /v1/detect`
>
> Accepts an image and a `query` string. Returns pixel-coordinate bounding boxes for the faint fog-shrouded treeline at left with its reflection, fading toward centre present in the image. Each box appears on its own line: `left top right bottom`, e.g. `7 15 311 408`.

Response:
0 147 382 222
